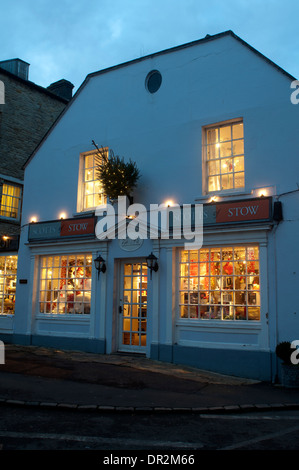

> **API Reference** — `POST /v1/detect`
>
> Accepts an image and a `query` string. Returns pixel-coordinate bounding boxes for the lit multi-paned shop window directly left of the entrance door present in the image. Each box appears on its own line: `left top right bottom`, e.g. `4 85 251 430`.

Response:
39 254 92 314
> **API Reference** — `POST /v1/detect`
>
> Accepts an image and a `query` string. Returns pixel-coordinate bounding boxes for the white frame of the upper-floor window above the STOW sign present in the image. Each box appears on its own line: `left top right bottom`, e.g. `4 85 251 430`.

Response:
202 118 246 196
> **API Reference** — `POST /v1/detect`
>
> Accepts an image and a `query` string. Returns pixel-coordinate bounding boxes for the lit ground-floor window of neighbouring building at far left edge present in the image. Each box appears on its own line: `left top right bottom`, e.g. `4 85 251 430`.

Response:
0 256 18 315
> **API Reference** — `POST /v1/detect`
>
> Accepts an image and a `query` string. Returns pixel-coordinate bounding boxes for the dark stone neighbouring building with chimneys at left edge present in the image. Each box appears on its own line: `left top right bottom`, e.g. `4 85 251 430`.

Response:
0 59 73 314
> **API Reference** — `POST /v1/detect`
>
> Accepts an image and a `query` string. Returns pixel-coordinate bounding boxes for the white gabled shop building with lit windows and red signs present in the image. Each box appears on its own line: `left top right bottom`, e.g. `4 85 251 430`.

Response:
0 31 299 380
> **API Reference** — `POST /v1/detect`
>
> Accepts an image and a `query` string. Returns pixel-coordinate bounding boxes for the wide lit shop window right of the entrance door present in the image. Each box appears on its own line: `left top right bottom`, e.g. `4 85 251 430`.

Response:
179 246 260 321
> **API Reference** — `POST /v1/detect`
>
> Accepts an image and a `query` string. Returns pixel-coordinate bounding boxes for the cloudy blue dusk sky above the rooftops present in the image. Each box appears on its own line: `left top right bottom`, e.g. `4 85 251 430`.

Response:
0 0 299 91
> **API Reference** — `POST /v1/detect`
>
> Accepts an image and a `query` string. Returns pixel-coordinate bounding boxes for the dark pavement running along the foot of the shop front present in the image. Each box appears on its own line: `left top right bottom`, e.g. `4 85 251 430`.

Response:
0 344 299 413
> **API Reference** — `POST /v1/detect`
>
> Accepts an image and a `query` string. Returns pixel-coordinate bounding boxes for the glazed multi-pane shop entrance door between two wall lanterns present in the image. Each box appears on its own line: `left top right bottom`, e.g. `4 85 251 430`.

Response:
118 260 147 353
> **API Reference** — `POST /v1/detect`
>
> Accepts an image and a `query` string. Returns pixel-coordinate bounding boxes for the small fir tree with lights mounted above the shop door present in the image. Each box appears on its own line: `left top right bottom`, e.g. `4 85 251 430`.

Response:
96 143 140 200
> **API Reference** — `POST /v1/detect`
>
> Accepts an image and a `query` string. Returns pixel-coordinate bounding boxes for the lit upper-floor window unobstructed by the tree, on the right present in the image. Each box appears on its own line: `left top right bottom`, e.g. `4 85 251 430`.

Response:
204 122 245 193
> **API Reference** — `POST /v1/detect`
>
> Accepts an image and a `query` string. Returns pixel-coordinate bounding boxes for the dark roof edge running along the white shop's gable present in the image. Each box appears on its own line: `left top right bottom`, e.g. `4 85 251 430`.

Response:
23 30 296 168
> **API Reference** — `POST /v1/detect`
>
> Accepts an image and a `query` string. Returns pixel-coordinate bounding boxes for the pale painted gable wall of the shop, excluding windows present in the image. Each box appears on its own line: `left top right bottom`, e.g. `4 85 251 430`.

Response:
12 36 299 360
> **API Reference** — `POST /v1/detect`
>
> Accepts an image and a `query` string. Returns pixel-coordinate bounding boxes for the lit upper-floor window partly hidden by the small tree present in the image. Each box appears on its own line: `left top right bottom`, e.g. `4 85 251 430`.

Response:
79 152 106 211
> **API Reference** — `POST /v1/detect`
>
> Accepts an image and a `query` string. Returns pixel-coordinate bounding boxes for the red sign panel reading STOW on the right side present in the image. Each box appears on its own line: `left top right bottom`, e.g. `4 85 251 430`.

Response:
216 198 271 223
